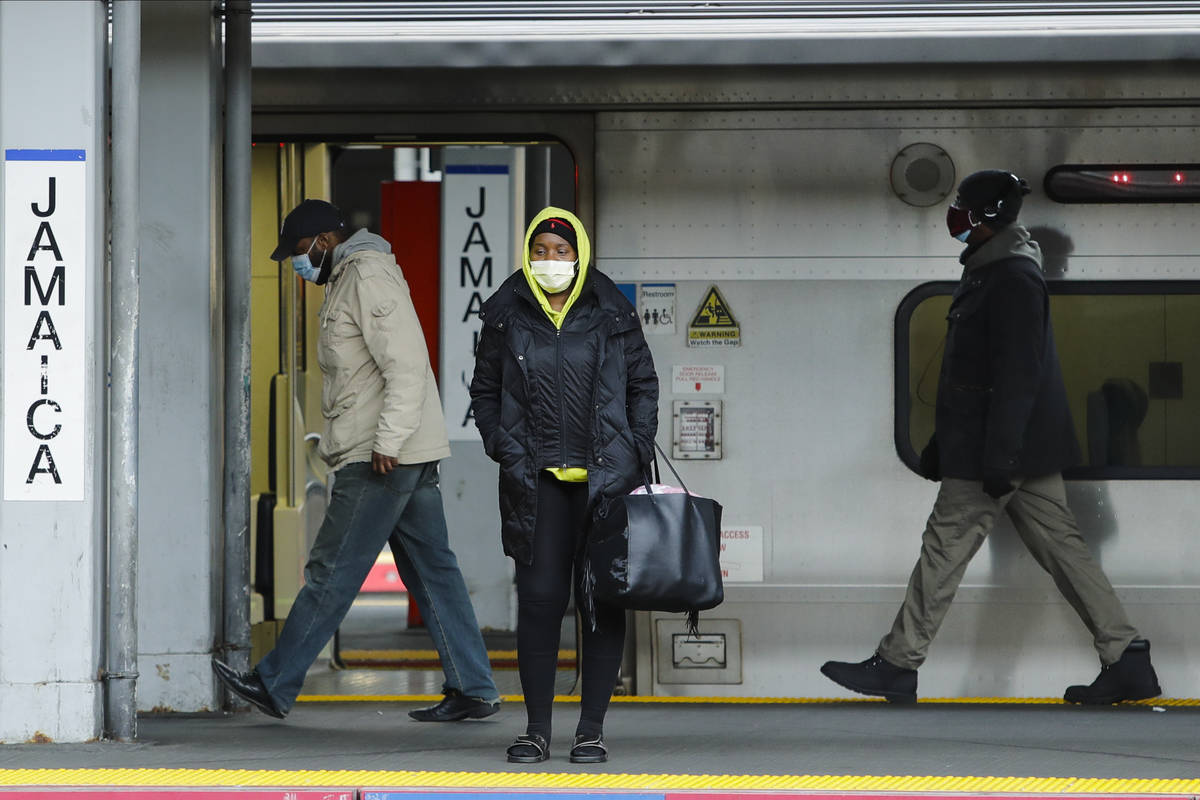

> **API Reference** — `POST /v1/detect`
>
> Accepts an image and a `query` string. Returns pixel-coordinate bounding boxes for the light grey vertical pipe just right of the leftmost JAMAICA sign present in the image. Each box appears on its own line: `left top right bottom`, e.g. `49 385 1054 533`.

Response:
104 0 142 741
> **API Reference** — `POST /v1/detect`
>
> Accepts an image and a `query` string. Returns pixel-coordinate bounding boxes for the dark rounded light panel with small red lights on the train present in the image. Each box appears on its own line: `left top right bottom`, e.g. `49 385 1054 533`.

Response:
1043 164 1200 203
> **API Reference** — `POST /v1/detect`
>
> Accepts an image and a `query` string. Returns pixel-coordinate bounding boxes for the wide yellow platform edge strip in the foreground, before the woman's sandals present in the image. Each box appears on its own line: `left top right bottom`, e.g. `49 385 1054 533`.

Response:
0 769 1200 795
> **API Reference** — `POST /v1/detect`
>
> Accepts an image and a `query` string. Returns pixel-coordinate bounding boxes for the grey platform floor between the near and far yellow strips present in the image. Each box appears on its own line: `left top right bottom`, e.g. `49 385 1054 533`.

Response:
0 670 1200 778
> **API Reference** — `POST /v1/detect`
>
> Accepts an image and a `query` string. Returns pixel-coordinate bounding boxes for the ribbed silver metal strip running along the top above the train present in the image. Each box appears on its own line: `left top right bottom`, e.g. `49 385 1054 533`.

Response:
253 1 1200 68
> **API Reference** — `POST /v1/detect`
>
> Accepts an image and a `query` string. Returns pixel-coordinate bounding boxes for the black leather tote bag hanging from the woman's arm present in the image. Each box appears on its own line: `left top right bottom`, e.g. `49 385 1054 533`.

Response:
583 443 725 631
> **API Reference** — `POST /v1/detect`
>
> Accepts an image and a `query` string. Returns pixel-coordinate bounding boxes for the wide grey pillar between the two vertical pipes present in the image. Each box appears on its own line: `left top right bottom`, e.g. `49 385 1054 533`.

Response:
137 0 223 711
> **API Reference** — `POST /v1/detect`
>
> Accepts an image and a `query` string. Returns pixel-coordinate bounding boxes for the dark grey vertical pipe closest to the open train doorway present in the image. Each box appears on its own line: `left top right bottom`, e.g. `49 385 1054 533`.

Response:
222 0 251 670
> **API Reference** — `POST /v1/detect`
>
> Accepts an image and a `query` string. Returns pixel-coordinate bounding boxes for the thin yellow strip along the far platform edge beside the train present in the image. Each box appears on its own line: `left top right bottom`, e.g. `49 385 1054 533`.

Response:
296 694 1200 708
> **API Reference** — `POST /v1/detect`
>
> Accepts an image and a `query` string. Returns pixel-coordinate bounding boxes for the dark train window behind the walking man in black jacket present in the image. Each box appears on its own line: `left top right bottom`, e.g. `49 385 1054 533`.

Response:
895 281 1200 480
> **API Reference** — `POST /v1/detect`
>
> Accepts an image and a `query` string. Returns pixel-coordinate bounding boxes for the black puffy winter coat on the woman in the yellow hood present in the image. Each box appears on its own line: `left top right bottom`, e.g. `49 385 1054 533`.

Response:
470 267 659 564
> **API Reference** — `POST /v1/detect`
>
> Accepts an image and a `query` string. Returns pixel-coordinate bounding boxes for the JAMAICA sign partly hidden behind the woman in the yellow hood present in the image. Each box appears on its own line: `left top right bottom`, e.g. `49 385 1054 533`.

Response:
440 159 514 441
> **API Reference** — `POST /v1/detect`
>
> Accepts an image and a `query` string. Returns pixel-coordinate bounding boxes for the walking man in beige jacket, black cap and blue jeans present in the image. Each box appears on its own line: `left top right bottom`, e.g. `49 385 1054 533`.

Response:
212 200 500 722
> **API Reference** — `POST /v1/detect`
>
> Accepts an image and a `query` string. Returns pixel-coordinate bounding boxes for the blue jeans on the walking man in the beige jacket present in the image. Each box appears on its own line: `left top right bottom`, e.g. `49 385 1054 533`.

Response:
258 462 499 712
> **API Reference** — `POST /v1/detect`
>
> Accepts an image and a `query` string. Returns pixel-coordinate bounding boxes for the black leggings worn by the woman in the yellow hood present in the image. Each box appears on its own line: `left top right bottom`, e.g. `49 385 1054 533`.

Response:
516 470 625 741
